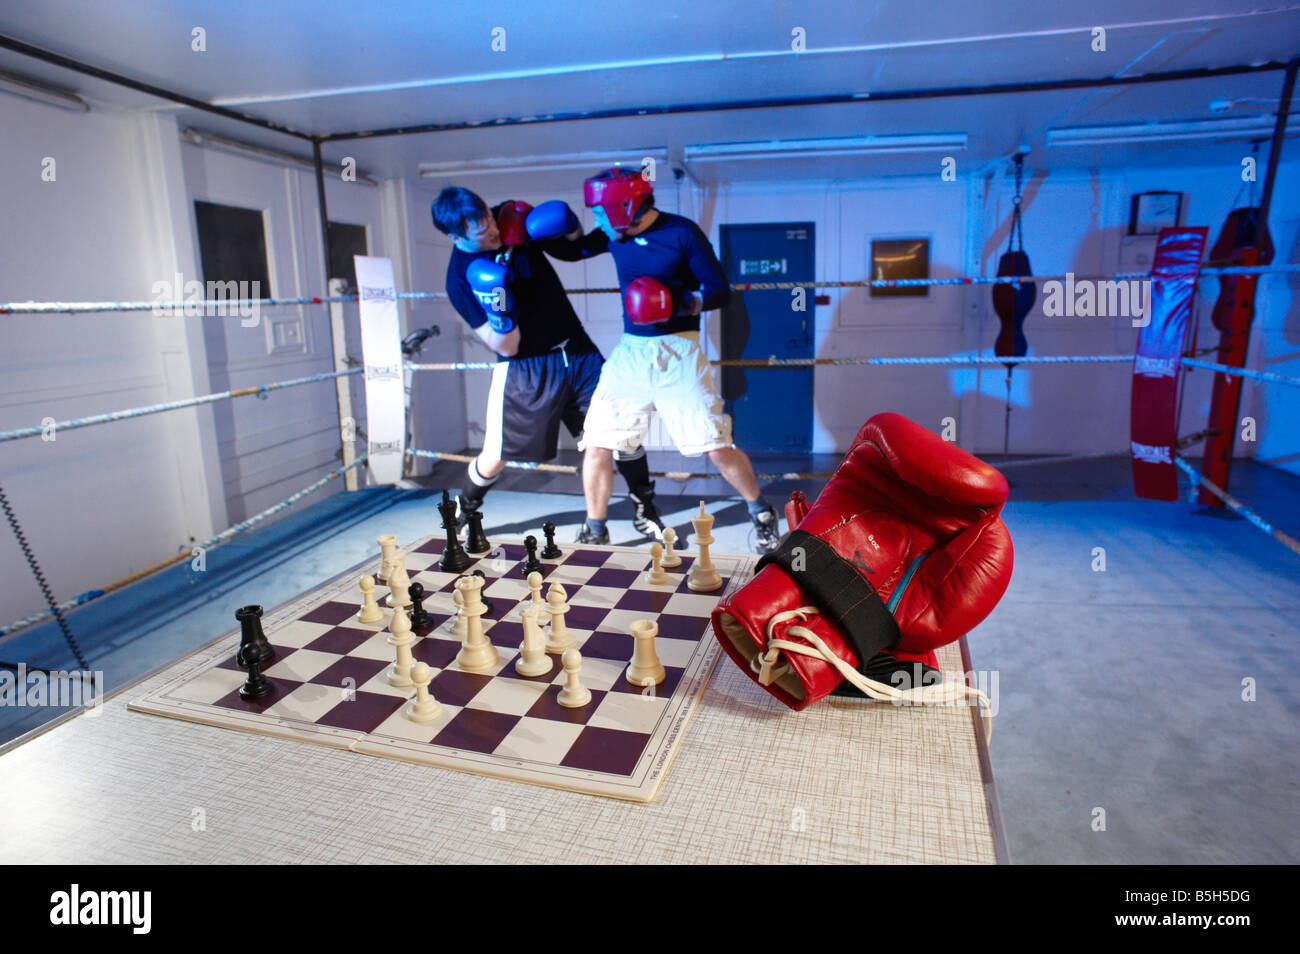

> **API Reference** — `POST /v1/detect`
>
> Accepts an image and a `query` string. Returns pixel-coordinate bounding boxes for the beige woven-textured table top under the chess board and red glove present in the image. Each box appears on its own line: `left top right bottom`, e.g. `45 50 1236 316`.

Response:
0 540 1006 864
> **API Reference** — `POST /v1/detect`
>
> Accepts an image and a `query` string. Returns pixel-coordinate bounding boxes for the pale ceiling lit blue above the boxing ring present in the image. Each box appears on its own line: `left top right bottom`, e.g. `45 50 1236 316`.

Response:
0 0 1300 188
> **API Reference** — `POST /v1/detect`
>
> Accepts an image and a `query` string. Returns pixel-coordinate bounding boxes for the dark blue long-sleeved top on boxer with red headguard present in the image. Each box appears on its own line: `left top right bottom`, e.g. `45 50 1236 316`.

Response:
545 212 731 338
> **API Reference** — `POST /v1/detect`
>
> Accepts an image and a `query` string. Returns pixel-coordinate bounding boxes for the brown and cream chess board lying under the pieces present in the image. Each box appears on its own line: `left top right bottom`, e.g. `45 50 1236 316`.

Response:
129 535 754 802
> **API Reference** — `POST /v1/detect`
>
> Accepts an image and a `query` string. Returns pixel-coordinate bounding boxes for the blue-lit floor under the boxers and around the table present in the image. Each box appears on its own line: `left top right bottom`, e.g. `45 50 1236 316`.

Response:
0 455 1300 864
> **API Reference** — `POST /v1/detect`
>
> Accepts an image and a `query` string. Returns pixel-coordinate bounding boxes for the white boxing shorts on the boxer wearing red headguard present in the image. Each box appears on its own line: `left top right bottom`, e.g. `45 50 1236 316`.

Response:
582 331 733 458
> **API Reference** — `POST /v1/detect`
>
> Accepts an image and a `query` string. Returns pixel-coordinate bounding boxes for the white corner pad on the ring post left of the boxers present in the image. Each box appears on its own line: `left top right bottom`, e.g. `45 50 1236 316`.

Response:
352 255 406 483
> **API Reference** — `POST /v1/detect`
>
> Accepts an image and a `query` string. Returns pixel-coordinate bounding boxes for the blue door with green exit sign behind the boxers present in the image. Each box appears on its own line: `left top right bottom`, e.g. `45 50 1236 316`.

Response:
720 222 815 454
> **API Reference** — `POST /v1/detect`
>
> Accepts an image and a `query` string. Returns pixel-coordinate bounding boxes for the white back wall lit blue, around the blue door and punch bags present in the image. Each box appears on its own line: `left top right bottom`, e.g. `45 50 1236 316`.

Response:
688 161 1300 467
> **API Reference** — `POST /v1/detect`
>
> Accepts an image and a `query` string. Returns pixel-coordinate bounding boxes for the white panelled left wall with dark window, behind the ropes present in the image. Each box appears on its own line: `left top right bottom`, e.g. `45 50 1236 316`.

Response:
0 96 416 623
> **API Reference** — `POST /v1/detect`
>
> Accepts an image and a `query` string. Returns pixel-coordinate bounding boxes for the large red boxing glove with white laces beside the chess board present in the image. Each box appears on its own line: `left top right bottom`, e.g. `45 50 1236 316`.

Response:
712 413 1013 727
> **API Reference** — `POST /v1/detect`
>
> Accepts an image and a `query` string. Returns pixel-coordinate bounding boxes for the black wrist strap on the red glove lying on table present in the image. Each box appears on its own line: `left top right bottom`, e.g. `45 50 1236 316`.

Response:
754 530 902 672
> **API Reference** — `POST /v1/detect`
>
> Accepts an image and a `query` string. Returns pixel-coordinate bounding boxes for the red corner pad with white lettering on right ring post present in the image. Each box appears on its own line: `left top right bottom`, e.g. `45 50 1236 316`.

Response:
1130 227 1209 500
